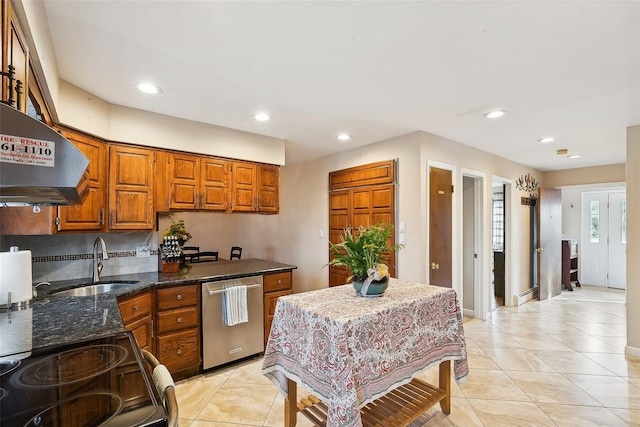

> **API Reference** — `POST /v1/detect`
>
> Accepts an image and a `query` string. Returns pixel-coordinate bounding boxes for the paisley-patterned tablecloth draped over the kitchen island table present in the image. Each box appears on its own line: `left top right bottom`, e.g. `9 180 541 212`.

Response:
262 279 469 427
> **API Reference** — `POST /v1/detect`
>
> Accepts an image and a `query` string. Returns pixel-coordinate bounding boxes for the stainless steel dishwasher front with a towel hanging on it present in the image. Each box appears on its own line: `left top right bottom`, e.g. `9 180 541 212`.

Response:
202 276 264 369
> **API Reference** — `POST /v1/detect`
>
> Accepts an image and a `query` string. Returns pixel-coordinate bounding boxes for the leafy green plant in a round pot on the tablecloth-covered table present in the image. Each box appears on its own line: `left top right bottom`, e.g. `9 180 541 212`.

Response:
327 223 404 295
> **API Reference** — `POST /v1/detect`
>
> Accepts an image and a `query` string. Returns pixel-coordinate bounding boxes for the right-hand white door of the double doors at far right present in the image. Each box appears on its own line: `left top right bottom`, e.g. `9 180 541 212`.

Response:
607 193 627 289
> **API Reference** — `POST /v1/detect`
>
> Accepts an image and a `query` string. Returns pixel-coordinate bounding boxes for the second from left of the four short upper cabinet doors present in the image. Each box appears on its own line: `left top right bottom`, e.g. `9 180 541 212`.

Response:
200 158 229 211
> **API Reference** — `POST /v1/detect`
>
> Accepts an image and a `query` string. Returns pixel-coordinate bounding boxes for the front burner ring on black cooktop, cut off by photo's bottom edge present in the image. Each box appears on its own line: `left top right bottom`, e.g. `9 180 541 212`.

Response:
24 393 122 427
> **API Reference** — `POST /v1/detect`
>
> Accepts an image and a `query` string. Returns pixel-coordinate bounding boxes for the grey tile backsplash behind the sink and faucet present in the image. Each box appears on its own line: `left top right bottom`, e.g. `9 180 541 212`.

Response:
2 232 158 282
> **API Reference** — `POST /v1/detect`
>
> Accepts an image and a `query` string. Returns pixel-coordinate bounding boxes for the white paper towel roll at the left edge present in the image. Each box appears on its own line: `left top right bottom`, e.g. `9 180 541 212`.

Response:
0 251 33 307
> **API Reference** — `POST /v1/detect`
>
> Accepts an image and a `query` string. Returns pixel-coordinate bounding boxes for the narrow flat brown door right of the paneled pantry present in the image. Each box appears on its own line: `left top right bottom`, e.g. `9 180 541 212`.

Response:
429 167 453 288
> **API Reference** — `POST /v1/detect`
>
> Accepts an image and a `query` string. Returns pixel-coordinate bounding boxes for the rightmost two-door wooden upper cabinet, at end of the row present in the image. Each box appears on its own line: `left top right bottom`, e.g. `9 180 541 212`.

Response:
231 162 280 213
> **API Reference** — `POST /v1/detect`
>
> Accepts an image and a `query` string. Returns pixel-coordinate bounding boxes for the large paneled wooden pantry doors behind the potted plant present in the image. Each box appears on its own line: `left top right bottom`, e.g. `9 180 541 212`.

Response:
329 161 396 286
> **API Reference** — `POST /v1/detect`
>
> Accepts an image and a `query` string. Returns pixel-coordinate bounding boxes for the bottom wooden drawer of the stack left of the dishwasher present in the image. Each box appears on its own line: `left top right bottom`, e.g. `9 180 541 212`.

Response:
158 328 200 373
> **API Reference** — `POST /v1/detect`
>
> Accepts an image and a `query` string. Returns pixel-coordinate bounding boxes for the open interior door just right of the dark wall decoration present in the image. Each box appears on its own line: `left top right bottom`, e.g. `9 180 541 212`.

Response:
536 187 562 300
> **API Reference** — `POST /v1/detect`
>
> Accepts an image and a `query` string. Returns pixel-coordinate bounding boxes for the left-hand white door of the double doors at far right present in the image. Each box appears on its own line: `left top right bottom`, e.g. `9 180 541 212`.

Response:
578 193 609 287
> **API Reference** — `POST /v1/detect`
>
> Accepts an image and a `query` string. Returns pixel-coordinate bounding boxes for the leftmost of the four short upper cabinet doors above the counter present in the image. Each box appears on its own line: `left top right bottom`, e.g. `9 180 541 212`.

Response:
169 154 200 209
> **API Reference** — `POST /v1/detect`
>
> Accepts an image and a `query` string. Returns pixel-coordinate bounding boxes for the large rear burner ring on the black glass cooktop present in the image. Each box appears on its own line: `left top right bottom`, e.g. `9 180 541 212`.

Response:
16 344 127 388
